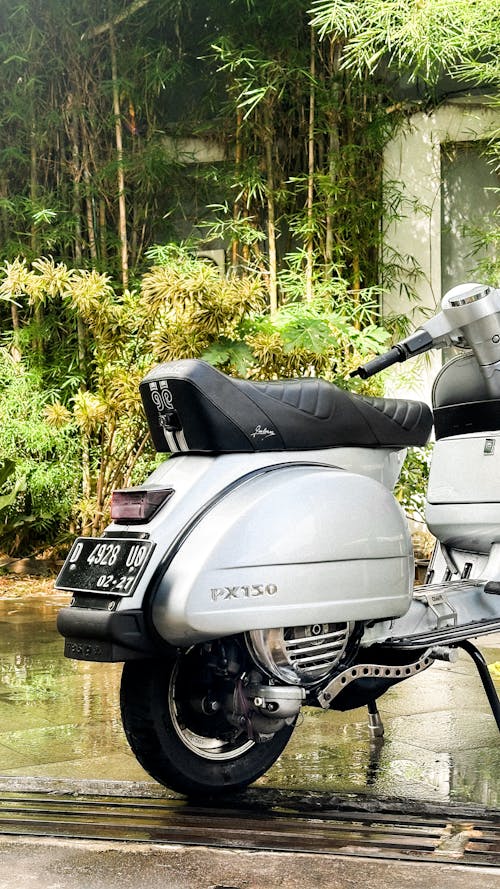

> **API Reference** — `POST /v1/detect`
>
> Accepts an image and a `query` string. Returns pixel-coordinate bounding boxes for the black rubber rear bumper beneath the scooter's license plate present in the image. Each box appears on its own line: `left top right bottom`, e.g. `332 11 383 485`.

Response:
57 605 158 663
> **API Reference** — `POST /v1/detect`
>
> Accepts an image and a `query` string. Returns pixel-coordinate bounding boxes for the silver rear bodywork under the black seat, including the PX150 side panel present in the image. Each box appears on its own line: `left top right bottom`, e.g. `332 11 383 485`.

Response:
108 448 413 645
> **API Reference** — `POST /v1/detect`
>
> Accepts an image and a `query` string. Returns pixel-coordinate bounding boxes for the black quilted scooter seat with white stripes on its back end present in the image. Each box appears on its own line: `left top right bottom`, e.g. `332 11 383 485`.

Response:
140 359 432 454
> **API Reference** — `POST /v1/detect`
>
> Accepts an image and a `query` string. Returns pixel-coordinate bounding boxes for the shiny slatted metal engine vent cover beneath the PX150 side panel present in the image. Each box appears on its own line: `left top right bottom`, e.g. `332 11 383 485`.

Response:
246 623 354 685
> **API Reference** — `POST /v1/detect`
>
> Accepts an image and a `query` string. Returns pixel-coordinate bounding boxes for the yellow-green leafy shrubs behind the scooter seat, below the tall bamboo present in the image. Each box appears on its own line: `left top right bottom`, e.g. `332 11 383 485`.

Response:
0 247 389 546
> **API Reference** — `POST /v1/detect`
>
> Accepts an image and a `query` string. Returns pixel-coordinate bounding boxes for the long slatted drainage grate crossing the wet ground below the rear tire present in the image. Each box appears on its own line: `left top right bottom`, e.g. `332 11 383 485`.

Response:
0 792 500 867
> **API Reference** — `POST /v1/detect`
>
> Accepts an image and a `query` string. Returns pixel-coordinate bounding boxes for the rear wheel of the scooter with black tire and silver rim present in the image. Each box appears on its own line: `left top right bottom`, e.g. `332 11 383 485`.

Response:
120 652 294 797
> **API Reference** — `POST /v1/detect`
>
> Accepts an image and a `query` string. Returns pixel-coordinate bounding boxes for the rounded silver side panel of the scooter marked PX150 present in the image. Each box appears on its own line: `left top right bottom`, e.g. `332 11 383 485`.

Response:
152 464 413 644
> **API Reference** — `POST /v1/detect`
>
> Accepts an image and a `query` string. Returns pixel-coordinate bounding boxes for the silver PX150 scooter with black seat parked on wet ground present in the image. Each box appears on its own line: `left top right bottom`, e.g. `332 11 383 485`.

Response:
56 284 500 795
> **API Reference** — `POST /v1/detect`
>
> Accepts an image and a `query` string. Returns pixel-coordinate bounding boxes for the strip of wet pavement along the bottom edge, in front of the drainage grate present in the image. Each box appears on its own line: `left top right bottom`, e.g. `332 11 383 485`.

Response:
0 839 500 889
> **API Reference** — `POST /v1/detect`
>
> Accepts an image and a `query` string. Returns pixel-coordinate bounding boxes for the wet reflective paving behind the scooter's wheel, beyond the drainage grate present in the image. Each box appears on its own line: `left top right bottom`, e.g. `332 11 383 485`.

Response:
0 598 500 807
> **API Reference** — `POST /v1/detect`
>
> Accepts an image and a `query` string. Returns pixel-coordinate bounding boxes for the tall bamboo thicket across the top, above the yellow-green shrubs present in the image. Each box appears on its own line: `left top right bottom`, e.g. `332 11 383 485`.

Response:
0 0 500 306
